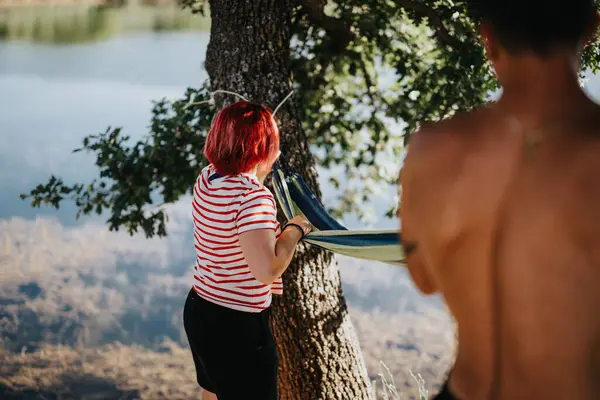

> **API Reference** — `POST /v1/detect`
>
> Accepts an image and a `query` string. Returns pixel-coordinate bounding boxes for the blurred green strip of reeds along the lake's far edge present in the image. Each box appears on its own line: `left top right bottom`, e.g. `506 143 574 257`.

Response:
0 4 210 44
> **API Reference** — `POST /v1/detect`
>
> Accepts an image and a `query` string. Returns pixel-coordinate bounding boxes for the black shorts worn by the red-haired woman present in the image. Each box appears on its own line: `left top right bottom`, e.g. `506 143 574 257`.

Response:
183 289 277 400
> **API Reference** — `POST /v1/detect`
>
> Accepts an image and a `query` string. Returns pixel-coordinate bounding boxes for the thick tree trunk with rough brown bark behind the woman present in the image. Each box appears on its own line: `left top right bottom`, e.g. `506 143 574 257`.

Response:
205 0 373 400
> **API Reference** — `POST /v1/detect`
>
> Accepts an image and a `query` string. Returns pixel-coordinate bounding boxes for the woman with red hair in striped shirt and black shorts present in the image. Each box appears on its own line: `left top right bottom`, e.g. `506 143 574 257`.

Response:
183 101 311 400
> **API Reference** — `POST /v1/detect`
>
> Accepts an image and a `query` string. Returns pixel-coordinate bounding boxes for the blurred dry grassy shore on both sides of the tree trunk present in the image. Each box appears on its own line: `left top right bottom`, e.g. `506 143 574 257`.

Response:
0 214 455 400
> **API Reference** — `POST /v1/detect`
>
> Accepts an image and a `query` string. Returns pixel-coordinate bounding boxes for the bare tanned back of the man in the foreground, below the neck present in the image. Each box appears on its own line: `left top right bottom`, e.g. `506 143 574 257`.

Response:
401 101 600 400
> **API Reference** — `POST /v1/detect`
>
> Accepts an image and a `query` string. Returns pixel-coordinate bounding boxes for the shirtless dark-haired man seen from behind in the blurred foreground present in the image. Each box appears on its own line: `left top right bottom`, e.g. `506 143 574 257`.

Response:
400 0 600 400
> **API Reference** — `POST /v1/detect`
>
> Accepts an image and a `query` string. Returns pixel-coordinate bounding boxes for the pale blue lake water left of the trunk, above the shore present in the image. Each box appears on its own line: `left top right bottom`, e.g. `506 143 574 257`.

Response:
0 32 208 224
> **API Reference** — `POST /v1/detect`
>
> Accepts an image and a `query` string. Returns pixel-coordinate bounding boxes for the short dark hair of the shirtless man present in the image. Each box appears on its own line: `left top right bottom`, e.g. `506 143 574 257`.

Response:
467 0 596 56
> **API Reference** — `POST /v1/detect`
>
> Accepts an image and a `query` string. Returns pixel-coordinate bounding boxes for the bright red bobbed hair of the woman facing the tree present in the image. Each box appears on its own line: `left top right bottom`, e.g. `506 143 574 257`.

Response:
204 101 279 175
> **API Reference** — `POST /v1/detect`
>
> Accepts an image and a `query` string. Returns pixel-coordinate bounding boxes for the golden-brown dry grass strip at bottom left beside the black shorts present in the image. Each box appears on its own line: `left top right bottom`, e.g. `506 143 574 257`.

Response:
0 343 200 400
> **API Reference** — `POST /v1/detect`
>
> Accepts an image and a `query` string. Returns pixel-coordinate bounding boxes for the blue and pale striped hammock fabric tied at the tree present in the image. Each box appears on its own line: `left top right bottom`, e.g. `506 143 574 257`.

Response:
273 164 405 266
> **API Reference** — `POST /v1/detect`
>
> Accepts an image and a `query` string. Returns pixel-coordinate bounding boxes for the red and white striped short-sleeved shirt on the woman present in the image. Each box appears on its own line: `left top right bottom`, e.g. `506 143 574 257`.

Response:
192 165 283 312
